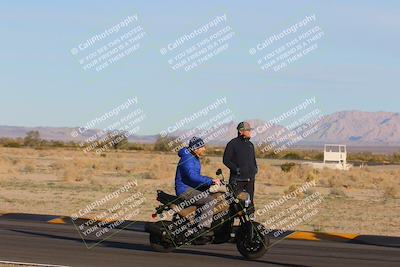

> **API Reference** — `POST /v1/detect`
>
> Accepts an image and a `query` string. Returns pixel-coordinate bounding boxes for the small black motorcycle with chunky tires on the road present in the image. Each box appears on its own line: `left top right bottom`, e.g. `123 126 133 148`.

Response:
145 169 270 260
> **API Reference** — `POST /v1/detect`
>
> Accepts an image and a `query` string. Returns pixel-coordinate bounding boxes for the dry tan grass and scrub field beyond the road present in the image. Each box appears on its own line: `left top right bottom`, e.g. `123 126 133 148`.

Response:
0 148 400 238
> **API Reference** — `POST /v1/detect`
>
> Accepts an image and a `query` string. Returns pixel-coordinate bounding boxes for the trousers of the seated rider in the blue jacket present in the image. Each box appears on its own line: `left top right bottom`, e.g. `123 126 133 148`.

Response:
180 189 215 228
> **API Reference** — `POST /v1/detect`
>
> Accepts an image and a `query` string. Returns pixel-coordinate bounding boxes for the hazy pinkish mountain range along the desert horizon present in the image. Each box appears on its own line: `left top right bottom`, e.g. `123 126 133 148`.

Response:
0 110 400 147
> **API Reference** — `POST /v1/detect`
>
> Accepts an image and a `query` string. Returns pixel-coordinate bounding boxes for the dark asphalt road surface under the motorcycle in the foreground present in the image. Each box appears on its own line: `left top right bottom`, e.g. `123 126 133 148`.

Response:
0 220 400 267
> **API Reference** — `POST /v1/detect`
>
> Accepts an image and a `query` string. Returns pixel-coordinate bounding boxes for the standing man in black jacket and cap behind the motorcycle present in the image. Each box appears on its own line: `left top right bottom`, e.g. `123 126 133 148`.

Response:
223 121 258 214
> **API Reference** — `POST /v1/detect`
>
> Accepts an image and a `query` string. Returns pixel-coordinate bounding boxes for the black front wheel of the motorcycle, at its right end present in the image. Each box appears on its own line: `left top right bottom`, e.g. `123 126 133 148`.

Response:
236 222 269 260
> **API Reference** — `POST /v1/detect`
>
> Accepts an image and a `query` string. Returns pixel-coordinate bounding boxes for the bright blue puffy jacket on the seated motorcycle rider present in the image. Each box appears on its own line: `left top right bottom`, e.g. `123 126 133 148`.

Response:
175 147 212 196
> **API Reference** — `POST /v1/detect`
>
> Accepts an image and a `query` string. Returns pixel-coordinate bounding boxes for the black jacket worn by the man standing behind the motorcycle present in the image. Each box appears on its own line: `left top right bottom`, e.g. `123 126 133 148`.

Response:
223 136 258 181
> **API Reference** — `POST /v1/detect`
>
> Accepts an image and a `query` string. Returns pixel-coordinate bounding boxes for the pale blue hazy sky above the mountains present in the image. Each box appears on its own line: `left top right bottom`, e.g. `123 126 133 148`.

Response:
0 1 400 134
